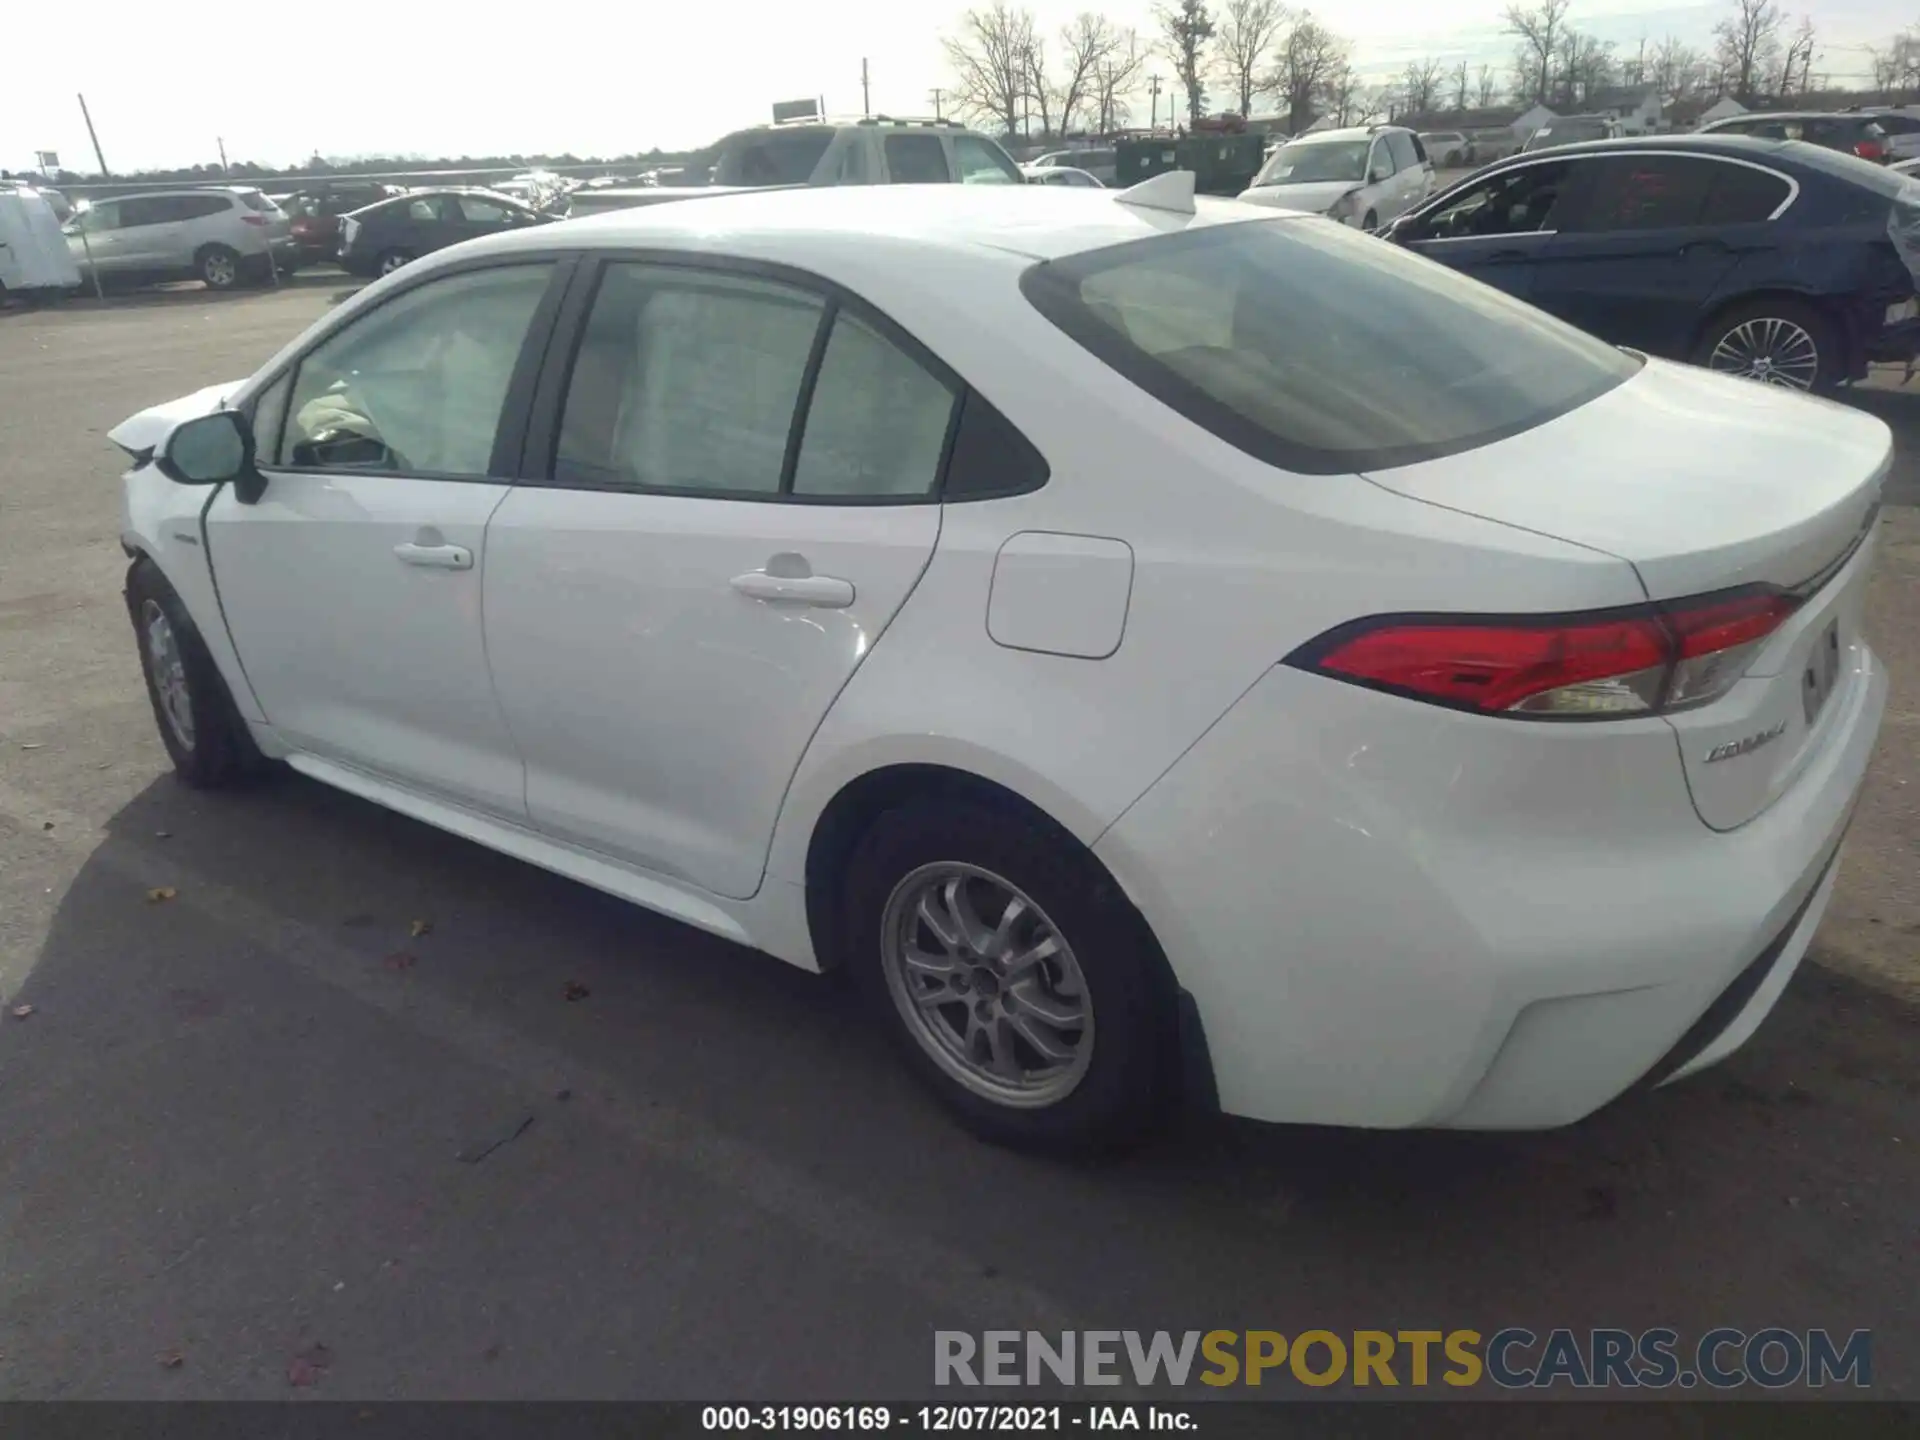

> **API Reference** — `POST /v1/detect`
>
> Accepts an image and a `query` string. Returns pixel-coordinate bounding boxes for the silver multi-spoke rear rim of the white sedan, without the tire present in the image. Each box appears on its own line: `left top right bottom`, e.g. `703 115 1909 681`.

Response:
879 860 1094 1110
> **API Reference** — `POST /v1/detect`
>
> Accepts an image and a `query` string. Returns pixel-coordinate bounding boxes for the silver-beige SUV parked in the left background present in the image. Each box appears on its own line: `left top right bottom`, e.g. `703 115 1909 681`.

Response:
63 184 294 290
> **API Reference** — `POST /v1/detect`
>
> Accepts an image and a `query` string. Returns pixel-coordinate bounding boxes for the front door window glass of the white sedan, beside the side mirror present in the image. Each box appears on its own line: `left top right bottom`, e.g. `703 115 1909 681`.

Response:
275 265 551 478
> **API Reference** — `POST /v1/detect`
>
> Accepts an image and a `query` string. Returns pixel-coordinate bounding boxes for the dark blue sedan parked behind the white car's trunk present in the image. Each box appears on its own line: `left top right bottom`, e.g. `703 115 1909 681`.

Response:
1388 134 1920 390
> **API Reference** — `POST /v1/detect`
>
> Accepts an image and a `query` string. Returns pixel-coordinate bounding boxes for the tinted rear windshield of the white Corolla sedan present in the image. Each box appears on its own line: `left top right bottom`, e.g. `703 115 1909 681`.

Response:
1021 219 1640 474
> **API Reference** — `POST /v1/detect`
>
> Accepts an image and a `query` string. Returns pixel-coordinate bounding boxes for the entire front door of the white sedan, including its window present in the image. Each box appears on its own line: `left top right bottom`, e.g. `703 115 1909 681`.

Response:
205 261 564 820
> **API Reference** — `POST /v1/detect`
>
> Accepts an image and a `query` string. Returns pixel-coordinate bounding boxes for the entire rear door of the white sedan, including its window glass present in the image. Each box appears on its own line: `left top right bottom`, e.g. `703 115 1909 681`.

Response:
484 261 956 899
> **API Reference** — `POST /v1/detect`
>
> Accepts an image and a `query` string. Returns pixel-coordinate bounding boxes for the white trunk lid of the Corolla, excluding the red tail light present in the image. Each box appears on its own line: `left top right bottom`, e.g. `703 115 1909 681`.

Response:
1367 361 1893 829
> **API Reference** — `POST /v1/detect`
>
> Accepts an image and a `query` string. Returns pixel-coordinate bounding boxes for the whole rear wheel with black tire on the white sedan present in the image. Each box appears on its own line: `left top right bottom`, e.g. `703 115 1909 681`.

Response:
843 795 1175 1154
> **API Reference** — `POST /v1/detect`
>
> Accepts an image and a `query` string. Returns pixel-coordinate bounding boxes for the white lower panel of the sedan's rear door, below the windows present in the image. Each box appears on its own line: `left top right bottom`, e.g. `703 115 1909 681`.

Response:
486 503 939 899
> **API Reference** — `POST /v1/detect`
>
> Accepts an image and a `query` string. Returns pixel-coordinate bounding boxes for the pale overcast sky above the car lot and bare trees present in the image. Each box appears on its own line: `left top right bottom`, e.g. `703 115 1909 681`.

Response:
0 0 1914 171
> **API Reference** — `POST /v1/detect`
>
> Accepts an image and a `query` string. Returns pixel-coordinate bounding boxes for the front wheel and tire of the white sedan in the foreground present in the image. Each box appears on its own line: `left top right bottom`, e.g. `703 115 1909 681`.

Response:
127 559 267 789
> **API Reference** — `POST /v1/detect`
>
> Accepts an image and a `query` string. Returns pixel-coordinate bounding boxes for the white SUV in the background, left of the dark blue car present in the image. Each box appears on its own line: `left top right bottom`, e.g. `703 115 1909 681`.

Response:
1240 125 1434 230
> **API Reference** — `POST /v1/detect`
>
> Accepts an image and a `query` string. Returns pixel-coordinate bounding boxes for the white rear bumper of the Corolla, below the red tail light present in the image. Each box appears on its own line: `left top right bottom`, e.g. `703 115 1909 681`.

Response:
1094 653 1887 1129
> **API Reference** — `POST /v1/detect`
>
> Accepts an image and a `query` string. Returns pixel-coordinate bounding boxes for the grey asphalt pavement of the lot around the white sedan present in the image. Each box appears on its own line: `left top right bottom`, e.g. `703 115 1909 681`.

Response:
0 278 1920 1400
